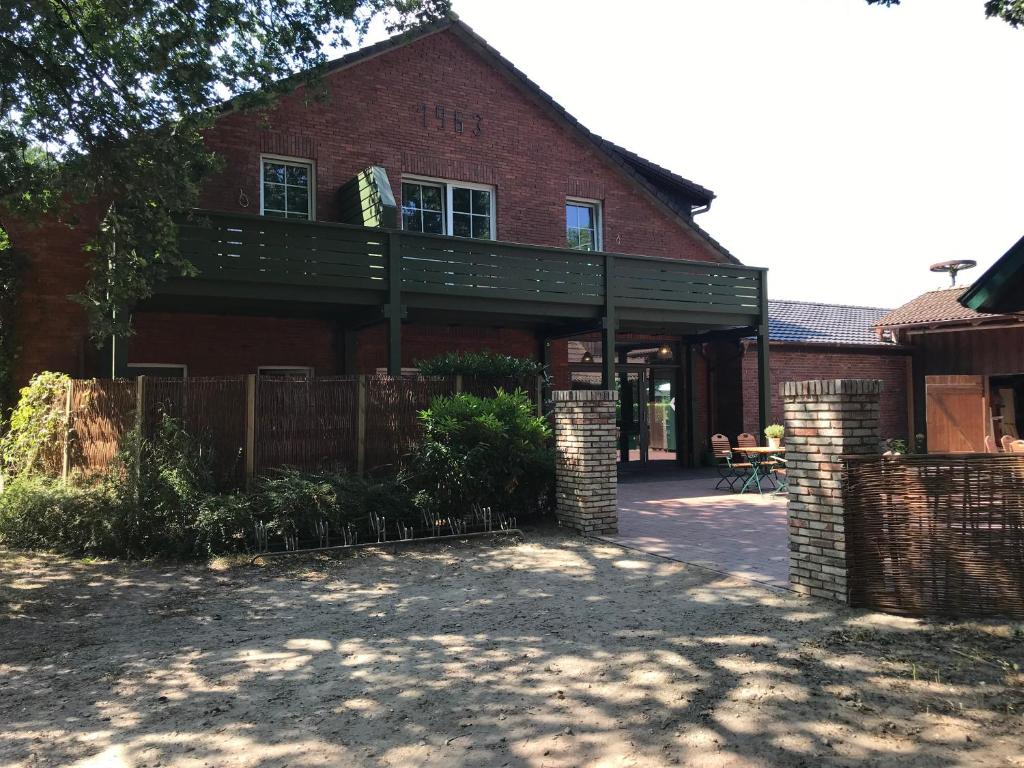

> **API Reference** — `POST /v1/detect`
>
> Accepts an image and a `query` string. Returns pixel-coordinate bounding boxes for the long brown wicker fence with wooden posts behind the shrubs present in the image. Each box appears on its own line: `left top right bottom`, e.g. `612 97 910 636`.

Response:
54 376 540 484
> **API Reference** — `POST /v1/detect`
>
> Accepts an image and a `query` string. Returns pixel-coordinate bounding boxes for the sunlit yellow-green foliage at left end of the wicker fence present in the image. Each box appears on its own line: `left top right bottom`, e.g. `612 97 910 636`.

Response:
0 371 71 477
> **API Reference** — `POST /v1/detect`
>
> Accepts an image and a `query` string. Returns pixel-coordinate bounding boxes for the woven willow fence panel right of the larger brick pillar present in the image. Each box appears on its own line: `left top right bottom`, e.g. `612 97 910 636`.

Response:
843 454 1024 618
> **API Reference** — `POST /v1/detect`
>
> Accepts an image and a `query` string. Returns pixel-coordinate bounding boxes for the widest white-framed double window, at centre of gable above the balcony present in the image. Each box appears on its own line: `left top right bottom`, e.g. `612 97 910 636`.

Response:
401 177 497 240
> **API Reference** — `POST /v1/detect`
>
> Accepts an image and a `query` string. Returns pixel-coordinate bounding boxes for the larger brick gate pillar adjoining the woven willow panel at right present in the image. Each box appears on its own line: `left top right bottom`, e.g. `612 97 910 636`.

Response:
780 379 882 603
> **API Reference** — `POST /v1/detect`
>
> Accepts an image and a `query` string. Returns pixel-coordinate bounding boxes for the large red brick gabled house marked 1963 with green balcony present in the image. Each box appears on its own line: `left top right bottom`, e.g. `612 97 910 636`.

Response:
2 16 767 460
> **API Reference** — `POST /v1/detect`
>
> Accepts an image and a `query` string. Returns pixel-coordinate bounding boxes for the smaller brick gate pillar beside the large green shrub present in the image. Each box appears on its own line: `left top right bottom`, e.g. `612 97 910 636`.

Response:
551 390 618 534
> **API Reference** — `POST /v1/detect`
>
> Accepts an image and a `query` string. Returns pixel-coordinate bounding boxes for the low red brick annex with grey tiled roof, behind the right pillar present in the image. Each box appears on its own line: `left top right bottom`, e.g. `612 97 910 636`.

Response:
741 299 913 439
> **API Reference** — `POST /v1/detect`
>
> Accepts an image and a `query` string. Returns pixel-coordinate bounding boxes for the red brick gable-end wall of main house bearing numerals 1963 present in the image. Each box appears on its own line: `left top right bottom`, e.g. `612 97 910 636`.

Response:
11 27 721 387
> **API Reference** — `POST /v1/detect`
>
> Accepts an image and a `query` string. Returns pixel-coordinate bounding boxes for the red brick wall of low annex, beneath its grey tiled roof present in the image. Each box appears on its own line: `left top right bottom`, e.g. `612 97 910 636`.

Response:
730 344 909 439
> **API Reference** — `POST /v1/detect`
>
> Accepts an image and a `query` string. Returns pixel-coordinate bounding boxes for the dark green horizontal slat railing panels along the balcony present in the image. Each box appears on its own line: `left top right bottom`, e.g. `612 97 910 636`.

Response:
180 212 763 317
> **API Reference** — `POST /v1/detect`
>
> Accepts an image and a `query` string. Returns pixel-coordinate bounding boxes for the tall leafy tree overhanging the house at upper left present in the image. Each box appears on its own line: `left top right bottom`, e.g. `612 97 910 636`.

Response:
0 0 450 338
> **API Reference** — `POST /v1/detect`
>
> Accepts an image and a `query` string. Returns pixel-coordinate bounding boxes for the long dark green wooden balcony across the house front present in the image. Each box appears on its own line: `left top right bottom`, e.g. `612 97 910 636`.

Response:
157 211 765 334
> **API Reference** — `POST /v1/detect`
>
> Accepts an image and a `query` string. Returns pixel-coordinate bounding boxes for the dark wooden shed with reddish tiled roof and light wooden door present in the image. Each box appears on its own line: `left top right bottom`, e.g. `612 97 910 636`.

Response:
877 286 1024 453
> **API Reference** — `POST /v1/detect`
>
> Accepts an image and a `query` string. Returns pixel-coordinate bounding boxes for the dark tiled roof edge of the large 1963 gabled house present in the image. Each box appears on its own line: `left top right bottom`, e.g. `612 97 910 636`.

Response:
235 12 740 264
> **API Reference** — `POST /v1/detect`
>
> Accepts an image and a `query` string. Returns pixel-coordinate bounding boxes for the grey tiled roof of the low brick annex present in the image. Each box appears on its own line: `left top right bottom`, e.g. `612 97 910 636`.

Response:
768 300 892 346
